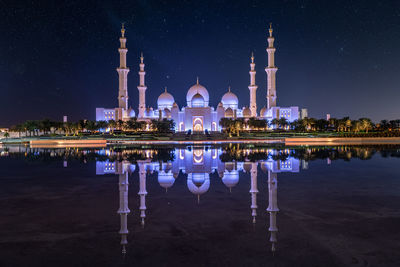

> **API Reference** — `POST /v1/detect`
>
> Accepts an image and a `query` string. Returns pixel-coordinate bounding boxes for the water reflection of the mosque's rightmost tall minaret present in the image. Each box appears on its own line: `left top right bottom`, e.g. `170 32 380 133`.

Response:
267 171 279 251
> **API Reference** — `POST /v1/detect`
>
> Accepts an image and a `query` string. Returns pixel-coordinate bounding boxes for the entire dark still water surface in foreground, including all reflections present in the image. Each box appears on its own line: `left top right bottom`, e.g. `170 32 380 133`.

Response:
0 145 400 266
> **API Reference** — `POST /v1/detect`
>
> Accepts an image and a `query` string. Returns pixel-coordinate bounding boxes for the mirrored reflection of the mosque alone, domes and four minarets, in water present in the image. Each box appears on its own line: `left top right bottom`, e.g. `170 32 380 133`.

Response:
96 147 299 253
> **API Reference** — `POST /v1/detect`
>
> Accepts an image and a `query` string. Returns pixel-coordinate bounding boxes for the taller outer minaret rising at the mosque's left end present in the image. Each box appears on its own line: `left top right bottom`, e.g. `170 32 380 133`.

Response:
117 24 129 110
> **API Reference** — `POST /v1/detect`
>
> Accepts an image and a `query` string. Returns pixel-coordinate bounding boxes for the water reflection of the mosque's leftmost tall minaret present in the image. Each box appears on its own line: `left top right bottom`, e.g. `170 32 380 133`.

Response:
118 172 130 254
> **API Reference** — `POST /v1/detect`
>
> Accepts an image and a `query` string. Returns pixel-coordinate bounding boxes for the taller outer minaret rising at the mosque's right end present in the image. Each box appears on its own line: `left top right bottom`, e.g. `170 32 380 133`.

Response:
265 23 278 109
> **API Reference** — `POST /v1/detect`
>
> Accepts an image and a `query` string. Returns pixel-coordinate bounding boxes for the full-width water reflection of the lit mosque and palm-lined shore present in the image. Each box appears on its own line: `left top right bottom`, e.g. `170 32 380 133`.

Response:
0 145 400 254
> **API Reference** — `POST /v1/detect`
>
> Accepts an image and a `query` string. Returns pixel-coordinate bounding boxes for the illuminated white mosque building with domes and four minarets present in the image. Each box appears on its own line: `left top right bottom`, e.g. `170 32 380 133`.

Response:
96 25 299 132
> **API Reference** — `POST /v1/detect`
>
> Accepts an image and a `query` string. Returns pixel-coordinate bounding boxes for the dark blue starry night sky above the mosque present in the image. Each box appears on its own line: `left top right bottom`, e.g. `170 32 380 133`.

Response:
0 0 400 127
